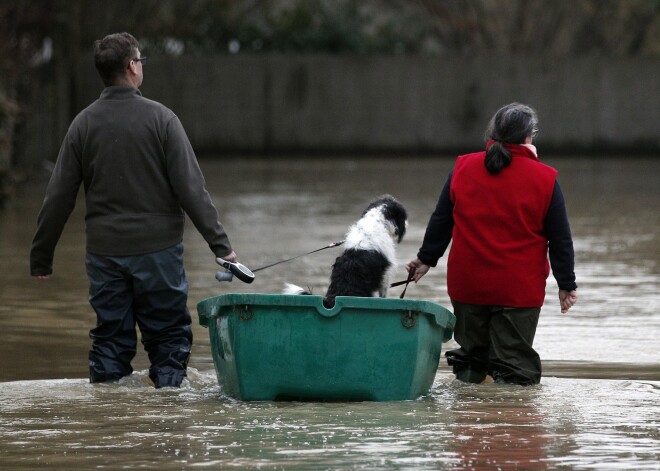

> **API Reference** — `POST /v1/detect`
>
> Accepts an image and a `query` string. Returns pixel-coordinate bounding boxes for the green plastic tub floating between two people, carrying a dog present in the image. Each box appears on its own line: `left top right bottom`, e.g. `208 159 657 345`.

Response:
197 294 456 401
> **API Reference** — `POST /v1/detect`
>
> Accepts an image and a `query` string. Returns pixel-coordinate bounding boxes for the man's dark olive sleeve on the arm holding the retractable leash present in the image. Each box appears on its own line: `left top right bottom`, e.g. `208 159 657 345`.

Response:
164 116 233 257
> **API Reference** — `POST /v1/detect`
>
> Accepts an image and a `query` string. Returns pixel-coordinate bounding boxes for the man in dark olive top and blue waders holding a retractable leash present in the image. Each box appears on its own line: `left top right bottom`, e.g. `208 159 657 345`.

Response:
30 33 237 388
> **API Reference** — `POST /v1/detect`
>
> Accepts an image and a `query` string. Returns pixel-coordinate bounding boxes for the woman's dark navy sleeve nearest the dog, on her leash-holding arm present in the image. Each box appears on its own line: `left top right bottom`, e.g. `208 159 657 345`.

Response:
417 171 454 267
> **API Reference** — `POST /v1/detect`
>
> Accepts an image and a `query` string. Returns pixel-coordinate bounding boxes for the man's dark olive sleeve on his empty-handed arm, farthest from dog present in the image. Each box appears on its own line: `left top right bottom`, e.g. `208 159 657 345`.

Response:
30 130 82 276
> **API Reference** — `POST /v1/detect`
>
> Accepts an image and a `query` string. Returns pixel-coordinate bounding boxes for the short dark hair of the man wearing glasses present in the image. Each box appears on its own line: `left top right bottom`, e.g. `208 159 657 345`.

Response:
94 33 140 87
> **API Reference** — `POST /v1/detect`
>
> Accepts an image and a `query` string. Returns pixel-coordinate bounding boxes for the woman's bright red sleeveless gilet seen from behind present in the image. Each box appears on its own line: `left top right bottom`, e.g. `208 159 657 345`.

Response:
447 144 557 307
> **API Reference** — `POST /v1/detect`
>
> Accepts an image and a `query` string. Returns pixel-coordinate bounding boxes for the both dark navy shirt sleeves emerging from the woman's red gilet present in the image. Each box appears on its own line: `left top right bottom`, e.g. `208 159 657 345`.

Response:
417 171 577 291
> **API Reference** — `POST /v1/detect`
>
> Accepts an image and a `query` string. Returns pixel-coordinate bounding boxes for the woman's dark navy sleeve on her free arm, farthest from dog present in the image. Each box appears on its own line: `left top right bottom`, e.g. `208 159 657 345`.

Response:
544 181 577 291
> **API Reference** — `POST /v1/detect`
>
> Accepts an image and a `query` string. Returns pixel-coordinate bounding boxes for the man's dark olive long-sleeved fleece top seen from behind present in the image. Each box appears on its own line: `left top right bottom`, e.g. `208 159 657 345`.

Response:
30 86 232 276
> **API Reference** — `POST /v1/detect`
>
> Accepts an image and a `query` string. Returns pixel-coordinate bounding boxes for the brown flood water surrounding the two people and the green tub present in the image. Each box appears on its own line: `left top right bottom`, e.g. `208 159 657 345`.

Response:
0 157 660 470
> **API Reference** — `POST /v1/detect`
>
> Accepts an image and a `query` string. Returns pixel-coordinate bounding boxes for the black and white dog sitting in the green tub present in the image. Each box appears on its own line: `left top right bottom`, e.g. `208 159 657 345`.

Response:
284 195 408 308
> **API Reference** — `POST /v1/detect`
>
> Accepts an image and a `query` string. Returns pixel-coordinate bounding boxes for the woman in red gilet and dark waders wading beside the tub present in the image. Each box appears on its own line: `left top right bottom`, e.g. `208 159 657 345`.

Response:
407 103 577 385
